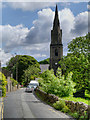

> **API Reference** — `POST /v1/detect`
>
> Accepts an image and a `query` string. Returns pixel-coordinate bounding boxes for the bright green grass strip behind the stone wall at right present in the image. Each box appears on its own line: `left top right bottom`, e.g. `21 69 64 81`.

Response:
62 97 90 105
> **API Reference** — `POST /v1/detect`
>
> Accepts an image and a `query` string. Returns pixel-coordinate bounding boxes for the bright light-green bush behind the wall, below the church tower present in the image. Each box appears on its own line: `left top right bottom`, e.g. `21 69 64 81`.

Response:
38 69 75 97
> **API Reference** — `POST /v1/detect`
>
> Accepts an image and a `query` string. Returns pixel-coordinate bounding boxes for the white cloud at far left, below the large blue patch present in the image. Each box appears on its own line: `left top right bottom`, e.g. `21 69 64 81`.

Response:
0 25 29 52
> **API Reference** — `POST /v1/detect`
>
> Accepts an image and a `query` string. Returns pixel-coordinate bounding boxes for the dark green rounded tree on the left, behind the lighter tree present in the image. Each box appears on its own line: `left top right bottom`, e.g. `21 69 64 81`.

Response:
7 55 39 83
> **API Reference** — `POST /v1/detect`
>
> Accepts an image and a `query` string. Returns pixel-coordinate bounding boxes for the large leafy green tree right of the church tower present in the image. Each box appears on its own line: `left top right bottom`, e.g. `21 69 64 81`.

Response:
59 34 90 97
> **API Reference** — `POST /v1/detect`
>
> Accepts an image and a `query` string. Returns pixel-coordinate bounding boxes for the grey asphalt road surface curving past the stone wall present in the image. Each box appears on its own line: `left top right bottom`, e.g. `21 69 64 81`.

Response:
4 88 74 120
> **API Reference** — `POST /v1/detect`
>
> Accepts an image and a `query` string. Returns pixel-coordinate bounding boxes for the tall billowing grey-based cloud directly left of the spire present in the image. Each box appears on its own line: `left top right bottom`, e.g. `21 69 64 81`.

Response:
25 8 54 44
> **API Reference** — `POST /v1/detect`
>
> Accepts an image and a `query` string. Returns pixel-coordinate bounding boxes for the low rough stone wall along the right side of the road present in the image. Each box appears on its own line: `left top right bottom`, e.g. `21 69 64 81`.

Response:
35 88 90 115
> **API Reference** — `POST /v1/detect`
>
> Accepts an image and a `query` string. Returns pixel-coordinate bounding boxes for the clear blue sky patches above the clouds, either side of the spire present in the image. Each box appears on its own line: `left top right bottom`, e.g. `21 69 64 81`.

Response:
2 2 88 28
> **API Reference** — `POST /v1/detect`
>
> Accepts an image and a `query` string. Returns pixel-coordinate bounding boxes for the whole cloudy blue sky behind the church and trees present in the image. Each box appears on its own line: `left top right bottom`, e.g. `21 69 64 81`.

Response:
0 0 90 66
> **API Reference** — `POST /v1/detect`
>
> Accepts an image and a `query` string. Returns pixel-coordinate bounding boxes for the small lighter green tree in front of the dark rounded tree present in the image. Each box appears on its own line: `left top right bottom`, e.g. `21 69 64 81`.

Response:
22 65 40 85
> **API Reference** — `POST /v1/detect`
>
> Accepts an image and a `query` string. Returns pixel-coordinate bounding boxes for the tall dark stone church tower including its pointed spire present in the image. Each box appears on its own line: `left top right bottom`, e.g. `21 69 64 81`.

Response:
50 5 63 74
